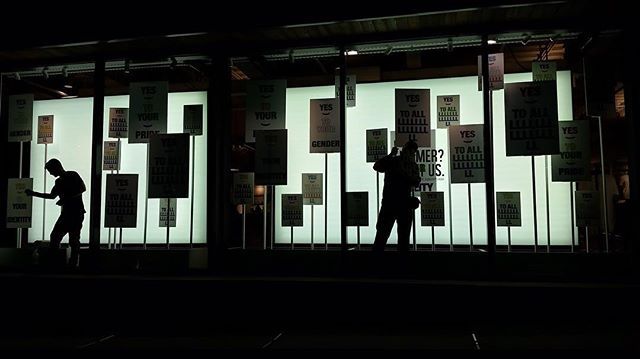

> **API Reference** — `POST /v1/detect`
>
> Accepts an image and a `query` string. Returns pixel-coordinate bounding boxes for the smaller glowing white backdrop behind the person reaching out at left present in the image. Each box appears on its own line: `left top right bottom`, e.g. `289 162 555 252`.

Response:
29 92 207 244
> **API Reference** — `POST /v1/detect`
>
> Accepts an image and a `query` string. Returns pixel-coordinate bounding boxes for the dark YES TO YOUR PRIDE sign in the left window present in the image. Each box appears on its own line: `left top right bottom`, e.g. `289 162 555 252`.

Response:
129 82 169 143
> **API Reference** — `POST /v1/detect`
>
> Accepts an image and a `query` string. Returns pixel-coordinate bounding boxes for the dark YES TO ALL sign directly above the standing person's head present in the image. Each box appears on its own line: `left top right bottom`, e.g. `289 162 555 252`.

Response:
395 89 431 147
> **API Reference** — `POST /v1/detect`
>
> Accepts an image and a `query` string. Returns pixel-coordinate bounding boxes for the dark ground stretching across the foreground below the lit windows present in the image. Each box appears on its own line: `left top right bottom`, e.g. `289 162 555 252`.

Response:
0 251 640 352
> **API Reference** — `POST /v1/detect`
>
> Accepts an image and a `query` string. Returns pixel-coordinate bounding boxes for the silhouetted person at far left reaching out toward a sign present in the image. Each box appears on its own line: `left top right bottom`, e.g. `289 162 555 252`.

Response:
25 158 87 267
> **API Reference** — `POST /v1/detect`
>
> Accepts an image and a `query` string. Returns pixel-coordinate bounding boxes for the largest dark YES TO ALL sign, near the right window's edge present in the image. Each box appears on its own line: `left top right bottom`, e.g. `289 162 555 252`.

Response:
504 81 559 156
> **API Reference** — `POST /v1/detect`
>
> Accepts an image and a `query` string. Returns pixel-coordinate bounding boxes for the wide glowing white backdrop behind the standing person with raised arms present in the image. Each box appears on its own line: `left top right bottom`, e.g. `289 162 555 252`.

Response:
275 71 573 245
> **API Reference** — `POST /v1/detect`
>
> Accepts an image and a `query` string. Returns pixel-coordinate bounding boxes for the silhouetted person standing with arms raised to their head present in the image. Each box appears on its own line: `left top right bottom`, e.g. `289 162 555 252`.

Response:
373 141 420 252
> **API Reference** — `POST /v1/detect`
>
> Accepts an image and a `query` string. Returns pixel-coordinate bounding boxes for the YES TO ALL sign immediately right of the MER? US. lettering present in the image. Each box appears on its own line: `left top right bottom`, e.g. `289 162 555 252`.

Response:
449 125 484 183
